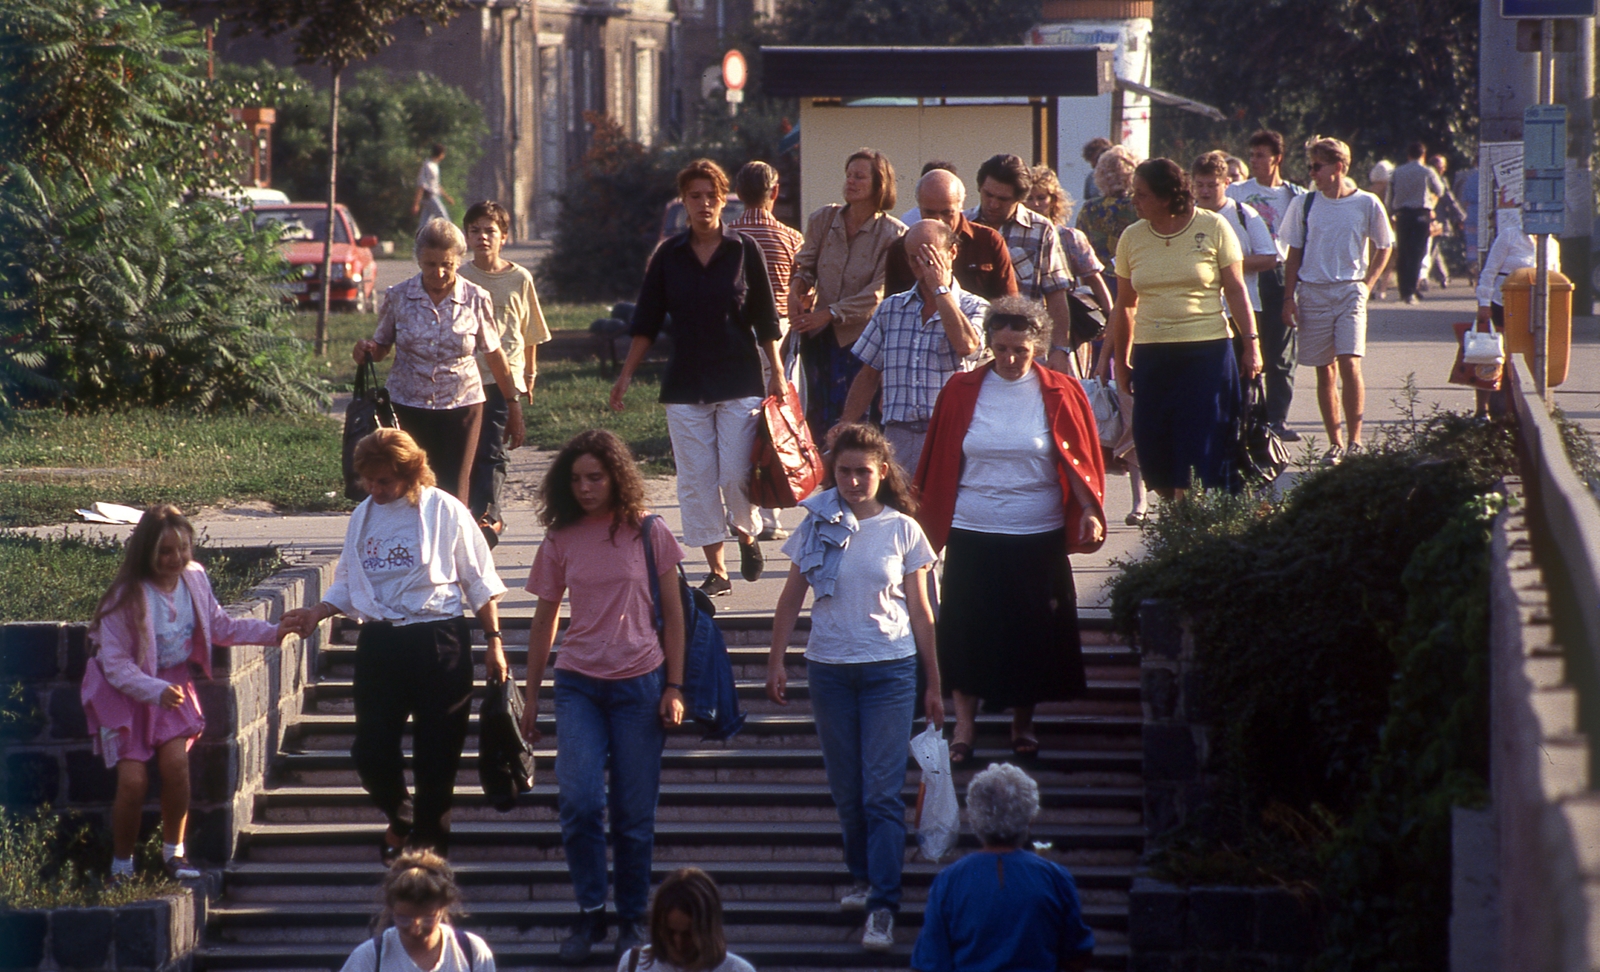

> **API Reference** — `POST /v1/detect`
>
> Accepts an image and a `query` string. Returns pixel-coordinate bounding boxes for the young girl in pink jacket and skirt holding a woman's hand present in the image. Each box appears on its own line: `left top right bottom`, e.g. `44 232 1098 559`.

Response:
82 504 298 881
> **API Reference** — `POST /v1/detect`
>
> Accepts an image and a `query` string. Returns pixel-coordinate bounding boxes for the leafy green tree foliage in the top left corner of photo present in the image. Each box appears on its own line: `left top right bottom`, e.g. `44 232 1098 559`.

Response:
0 0 253 189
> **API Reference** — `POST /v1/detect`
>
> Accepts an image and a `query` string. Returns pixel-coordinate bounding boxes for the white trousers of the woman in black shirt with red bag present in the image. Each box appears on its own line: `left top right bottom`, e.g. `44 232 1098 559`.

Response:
667 398 762 547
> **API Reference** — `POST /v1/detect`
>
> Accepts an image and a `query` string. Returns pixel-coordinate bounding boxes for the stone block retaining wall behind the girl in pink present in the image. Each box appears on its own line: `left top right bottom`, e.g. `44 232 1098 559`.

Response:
0 550 338 865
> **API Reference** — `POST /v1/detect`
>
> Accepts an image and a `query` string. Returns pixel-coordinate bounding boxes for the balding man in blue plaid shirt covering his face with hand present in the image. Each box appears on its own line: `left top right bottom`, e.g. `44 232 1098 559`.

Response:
840 219 989 472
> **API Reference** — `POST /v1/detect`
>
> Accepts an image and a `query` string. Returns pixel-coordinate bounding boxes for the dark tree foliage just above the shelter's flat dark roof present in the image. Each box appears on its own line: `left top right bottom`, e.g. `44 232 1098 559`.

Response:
774 0 1043 46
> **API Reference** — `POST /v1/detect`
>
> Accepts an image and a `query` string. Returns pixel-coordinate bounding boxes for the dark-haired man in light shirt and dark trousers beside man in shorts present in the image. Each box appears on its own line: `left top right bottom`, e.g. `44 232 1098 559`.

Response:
1227 128 1306 443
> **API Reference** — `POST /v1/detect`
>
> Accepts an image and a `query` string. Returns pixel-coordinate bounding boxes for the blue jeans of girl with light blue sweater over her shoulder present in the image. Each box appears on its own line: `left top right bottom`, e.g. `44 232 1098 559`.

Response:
806 655 917 911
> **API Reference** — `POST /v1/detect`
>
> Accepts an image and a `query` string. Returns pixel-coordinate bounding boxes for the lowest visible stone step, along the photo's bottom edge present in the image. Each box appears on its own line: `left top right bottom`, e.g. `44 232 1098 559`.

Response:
194 940 1128 972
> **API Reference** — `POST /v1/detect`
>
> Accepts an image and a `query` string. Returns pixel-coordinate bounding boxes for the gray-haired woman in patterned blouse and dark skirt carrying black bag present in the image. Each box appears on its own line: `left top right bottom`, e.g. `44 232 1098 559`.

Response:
352 219 523 502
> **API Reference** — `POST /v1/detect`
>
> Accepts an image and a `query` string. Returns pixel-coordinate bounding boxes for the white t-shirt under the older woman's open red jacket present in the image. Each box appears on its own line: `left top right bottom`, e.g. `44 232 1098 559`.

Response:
947 368 1067 533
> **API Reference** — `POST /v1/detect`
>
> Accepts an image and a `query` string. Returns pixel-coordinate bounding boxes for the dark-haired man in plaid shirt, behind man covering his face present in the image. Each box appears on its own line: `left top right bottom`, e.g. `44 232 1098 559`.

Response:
966 153 1072 374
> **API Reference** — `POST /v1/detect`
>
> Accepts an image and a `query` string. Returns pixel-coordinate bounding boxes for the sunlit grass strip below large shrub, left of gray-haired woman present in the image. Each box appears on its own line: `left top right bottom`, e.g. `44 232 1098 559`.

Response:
0 409 350 526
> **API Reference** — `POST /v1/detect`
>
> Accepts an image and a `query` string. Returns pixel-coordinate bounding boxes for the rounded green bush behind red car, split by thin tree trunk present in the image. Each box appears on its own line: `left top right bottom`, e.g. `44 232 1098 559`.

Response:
218 61 488 240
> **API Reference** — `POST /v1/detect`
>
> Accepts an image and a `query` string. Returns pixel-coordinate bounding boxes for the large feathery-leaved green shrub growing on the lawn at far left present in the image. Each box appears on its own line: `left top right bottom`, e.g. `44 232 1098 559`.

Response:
0 165 322 411
